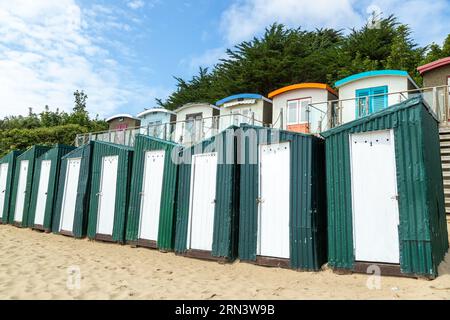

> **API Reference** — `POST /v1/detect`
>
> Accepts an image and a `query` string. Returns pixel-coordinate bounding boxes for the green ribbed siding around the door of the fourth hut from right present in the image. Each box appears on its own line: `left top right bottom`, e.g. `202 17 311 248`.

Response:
126 135 179 250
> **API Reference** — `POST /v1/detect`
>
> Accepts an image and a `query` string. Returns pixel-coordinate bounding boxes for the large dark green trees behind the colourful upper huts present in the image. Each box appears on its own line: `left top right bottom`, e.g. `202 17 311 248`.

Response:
157 16 450 110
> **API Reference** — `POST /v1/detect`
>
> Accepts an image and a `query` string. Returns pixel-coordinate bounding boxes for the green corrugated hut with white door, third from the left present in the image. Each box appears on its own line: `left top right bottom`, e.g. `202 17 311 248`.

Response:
28 144 75 232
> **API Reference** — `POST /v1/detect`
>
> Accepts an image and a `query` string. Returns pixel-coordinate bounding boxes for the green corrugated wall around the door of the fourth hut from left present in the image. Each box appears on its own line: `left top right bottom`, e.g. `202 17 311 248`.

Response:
52 142 93 238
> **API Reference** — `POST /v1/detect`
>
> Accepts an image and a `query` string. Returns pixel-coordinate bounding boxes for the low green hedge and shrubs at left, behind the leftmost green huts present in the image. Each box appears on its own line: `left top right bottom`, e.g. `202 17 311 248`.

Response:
0 91 108 156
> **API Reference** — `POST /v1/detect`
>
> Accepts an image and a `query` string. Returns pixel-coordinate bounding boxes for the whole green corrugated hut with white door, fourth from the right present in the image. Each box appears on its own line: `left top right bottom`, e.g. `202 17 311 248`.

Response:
126 135 180 250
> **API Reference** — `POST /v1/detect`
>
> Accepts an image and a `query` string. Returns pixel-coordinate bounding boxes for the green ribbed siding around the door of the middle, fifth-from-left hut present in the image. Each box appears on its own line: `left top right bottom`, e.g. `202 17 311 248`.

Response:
87 141 133 243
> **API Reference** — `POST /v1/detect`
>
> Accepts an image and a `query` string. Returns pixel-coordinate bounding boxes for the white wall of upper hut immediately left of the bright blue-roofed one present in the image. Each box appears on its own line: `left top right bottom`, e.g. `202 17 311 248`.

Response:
174 104 217 143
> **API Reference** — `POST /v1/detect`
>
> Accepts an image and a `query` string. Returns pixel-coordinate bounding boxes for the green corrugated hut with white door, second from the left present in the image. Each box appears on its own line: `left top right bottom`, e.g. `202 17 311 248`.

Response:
9 146 50 227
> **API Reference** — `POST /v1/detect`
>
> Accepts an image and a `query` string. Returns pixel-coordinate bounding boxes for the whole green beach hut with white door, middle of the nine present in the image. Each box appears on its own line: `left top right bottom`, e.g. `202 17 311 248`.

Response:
87 141 133 243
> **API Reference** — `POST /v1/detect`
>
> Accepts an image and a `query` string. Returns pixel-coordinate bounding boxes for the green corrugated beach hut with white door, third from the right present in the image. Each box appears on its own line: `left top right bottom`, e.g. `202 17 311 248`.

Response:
175 127 239 261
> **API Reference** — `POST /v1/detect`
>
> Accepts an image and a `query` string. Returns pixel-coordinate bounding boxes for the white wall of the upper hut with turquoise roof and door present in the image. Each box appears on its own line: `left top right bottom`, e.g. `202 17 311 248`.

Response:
339 76 409 123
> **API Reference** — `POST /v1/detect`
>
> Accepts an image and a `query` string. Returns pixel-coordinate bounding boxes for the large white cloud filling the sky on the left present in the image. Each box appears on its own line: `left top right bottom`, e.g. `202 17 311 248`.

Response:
0 0 167 117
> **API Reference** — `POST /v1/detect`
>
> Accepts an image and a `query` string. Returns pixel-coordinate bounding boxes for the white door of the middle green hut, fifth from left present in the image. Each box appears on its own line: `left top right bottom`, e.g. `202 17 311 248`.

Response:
97 156 119 236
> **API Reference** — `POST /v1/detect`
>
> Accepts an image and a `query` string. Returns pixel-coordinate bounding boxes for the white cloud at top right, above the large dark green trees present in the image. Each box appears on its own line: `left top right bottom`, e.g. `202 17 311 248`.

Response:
221 0 450 45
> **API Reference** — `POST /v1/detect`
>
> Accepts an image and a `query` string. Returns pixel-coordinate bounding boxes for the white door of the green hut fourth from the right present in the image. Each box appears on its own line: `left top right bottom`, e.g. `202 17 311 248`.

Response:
139 150 166 241
